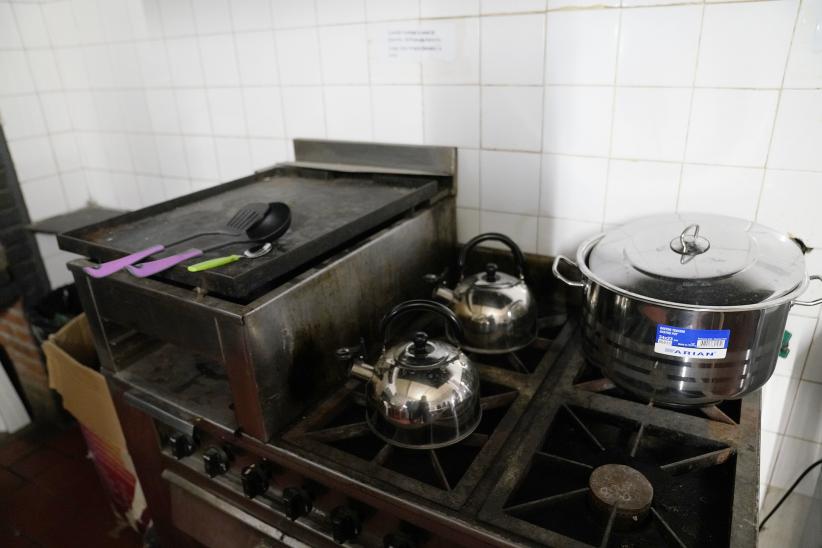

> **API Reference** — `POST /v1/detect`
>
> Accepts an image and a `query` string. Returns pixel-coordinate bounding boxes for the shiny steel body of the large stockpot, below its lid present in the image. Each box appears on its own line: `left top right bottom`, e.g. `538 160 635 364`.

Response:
582 282 790 405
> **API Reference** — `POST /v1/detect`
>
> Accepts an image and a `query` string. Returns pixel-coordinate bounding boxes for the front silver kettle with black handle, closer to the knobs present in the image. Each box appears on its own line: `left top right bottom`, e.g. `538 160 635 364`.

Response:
337 300 482 449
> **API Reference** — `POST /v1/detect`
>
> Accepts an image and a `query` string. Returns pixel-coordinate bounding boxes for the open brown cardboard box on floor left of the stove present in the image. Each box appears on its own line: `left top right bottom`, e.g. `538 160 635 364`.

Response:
43 314 149 531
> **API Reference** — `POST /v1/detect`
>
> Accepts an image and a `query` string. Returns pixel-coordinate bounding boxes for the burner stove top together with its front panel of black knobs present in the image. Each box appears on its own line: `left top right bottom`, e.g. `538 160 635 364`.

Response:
125 306 759 547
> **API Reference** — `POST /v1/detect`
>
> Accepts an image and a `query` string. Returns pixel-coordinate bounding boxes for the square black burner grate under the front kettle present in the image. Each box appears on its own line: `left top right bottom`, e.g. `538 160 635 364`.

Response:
284 380 519 505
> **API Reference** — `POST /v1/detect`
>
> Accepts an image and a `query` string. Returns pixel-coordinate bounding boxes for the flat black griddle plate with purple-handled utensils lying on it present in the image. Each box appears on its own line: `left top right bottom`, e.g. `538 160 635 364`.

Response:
58 168 437 298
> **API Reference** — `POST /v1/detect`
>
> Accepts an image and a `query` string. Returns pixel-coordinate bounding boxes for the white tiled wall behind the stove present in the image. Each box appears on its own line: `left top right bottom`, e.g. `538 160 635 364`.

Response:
0 0 822 496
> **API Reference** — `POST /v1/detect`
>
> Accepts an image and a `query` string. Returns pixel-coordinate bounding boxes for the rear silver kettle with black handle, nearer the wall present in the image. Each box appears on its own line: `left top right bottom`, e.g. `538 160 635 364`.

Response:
426 232 537 354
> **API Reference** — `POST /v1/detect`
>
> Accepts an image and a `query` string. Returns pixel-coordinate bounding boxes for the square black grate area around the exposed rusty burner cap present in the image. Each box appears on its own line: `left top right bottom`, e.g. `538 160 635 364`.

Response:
503 404 735 547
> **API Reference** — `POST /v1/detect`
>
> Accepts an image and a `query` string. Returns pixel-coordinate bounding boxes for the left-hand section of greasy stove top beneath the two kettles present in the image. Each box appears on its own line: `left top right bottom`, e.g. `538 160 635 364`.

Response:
283 322 567 508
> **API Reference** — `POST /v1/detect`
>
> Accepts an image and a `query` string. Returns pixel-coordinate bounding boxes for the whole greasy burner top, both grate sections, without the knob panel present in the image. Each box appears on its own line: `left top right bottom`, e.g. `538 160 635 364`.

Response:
282 310 759 547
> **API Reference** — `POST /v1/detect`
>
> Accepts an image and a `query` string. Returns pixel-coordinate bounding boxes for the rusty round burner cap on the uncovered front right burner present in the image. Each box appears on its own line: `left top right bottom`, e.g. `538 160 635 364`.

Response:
588 464 654 522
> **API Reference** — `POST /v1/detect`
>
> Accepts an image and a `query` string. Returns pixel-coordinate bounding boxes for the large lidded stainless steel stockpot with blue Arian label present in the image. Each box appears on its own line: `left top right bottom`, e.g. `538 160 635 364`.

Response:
553 215 818 406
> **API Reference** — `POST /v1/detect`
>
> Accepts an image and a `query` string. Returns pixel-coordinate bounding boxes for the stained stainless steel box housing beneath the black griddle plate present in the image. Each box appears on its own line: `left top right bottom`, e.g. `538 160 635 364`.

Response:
70 144 456 440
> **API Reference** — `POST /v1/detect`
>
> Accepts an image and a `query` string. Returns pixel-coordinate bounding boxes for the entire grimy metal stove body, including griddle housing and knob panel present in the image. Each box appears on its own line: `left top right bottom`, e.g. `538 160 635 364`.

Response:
61 140 759 548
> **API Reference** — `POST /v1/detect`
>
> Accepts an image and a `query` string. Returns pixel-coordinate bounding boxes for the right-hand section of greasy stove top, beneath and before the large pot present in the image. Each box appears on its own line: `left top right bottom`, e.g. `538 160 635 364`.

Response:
479 328 759 547
